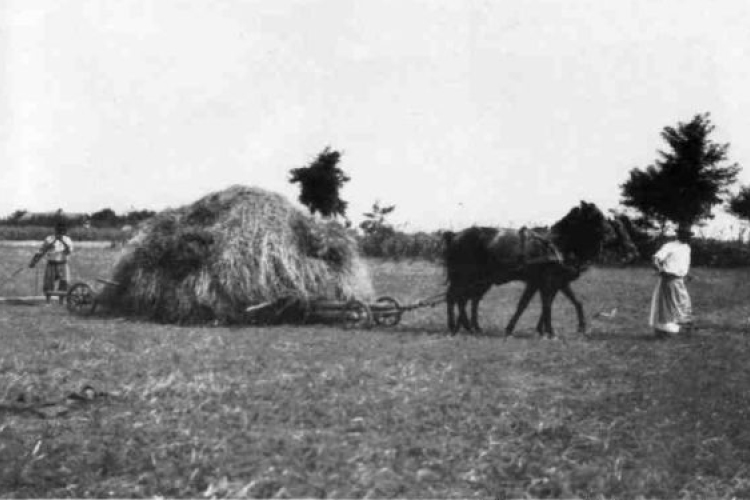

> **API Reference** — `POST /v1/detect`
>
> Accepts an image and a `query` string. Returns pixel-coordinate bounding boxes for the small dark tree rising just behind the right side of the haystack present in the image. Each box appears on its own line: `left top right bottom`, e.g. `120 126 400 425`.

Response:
289 146 350 217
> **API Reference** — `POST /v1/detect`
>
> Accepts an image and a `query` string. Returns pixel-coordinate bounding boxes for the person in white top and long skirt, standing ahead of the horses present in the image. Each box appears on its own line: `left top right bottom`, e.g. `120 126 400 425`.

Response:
649 226 693 339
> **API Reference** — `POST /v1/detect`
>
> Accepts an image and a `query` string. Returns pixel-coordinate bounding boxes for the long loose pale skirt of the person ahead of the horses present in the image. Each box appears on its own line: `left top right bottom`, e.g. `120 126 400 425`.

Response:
648 276 692 333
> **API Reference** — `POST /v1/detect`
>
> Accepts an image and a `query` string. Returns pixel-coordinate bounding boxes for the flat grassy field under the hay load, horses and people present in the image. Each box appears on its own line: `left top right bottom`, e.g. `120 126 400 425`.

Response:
0 248 750 498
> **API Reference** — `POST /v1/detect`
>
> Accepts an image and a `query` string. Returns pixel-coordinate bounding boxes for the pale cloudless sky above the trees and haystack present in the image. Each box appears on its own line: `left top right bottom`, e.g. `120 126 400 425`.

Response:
0 0 750 235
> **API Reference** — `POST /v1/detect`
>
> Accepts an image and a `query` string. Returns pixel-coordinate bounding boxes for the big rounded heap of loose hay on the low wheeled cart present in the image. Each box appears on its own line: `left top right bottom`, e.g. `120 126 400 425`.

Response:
100 186 373 323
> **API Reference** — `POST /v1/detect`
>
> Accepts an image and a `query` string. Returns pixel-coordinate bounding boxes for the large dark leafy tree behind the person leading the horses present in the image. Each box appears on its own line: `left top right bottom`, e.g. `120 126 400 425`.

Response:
620 113 740 228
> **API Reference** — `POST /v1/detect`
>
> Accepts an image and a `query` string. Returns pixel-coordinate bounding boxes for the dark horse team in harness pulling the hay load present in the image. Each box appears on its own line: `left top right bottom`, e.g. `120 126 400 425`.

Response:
443 201 638 337
